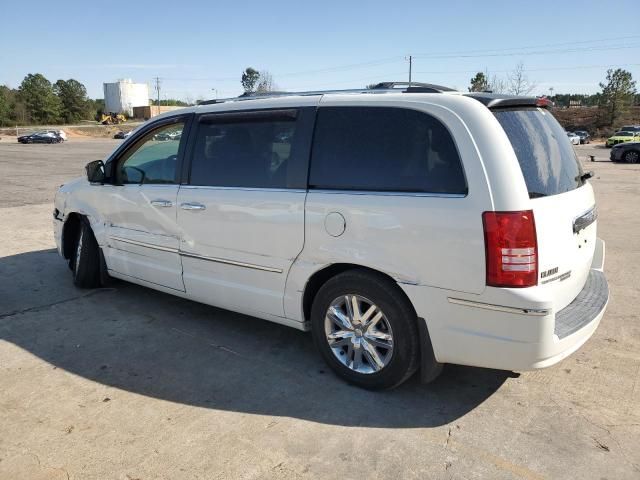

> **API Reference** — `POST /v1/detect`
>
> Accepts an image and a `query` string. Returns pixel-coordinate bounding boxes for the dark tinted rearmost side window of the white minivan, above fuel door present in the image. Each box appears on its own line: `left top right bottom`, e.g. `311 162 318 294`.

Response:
309 107 467 195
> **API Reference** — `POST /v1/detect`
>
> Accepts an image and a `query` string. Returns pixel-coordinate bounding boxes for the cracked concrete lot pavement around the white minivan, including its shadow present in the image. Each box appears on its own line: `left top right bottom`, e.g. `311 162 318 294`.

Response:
0 139 640 480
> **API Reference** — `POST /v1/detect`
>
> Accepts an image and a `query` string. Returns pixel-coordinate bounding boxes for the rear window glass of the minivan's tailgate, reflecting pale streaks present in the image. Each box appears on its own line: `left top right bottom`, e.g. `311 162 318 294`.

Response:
494 108 584 198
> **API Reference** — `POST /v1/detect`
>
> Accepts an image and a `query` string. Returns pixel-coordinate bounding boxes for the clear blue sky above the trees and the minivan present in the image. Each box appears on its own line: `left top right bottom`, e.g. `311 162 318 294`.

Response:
0 0 640 100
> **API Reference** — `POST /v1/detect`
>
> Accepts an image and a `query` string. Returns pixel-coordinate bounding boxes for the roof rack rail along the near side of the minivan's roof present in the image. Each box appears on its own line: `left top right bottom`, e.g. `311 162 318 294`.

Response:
198 82 455 105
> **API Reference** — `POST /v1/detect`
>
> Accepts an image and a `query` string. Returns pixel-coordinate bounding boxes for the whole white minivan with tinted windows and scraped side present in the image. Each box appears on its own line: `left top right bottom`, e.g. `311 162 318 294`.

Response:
53 84 609 388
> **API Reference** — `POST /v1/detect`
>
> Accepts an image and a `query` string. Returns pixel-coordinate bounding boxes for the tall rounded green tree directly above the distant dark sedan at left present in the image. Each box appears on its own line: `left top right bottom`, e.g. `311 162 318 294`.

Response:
18 73 62 124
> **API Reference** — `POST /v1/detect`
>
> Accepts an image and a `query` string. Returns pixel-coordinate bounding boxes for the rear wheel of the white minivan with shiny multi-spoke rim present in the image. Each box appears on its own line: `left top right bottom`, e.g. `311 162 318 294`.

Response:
311 270 420 390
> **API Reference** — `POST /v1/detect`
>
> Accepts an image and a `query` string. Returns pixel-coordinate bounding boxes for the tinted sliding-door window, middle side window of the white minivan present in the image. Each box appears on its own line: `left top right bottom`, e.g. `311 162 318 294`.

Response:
189 110 300 188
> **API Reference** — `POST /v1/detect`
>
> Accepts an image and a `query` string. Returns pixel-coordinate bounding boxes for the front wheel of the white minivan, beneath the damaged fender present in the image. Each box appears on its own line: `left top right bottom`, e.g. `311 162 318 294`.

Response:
69 218 100 288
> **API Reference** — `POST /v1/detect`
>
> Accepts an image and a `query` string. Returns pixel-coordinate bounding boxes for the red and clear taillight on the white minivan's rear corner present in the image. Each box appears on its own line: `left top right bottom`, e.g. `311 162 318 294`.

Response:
482 210 538 287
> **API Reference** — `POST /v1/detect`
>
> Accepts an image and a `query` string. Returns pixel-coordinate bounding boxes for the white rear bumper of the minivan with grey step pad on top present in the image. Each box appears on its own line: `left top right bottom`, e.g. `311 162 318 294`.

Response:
401 239 609 370
